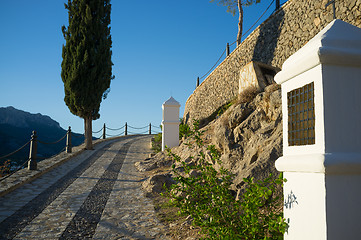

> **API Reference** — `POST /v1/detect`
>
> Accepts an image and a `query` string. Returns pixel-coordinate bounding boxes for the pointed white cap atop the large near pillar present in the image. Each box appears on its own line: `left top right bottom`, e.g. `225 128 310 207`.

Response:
275 19 361 84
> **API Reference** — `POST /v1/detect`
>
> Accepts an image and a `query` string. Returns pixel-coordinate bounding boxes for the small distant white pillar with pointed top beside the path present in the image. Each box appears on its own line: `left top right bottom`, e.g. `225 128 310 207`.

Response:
162 97 180 151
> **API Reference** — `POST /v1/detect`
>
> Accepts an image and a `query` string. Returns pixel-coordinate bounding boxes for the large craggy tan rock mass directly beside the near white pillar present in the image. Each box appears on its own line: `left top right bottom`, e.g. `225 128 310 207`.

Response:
212 89 282 187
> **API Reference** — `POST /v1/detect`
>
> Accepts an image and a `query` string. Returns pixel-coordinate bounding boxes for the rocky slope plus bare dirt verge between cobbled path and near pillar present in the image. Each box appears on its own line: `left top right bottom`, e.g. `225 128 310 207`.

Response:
136 85 282 239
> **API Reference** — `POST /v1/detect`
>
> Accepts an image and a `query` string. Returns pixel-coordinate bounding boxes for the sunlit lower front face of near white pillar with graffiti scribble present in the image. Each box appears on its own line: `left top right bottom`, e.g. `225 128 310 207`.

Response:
283 172 327 240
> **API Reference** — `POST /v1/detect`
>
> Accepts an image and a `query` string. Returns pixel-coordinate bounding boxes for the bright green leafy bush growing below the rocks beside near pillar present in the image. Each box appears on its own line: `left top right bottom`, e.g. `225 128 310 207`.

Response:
165 122 287 239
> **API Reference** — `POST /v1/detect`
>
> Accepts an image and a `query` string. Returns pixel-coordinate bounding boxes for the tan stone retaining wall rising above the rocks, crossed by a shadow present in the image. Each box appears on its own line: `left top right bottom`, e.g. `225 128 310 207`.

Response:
183 0 361 123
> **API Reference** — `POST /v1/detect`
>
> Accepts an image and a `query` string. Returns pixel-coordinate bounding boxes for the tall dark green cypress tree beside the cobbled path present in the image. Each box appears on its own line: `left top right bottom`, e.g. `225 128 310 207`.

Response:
61 0 114 149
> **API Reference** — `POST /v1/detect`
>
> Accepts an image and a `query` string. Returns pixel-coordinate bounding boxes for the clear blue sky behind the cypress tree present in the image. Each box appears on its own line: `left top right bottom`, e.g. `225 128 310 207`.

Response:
0 0 285 136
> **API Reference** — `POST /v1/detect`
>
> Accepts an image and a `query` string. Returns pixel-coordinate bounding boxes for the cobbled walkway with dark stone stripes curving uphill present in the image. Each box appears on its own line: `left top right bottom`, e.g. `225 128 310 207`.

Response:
0 136 168 239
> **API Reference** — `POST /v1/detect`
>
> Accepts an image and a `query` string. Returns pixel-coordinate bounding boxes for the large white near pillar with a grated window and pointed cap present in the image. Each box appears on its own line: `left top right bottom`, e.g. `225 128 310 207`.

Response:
275 20 361 240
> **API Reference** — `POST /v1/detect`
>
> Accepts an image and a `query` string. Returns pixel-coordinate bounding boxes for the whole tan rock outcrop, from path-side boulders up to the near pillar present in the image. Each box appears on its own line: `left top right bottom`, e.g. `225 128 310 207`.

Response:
136 85 282 195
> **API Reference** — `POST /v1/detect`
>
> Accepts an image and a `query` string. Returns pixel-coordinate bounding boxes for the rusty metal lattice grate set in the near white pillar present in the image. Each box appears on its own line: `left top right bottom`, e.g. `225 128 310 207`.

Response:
287 82 315 146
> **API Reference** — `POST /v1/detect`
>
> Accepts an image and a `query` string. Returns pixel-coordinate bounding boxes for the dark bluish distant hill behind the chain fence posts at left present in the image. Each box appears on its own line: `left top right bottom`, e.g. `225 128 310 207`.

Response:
0 107 84 165
